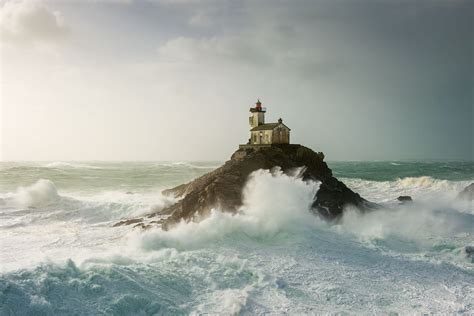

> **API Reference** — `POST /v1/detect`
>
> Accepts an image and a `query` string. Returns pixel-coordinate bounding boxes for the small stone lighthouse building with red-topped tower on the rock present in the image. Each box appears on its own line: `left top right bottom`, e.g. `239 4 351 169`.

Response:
248 100 291 146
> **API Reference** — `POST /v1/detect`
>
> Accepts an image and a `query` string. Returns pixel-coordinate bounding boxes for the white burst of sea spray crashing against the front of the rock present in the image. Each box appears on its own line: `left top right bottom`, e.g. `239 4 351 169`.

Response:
140 169 319 249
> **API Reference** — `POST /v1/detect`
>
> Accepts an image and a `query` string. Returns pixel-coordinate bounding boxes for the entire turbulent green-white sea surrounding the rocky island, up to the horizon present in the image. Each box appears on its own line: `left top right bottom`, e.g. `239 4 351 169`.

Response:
0 161 474 315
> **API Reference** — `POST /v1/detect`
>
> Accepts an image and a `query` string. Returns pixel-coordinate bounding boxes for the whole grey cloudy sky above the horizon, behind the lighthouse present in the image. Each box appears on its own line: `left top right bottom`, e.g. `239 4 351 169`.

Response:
0 0 474 160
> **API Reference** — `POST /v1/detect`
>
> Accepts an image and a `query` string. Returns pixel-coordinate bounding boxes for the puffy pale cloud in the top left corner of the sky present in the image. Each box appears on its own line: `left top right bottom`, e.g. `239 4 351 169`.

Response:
0 0 68 45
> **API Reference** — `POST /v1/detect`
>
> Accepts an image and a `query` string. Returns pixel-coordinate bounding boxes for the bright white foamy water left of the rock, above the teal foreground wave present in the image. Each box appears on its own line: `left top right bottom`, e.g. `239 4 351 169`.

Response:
0 179 178 271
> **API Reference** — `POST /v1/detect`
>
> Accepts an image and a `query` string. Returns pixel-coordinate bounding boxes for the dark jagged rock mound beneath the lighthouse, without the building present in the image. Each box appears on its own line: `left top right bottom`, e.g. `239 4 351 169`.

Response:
149 145 376 229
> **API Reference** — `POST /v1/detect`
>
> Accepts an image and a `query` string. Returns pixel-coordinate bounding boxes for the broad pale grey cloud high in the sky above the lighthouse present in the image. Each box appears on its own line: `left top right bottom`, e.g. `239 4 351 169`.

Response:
158 23 347 78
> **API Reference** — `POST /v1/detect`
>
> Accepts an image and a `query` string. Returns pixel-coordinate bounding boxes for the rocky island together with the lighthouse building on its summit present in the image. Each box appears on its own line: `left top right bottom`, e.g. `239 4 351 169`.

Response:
116 101 377 229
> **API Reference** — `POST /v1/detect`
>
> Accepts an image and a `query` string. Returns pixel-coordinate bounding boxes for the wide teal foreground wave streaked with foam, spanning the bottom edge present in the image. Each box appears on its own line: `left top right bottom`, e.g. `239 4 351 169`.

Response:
0 234 473 315
